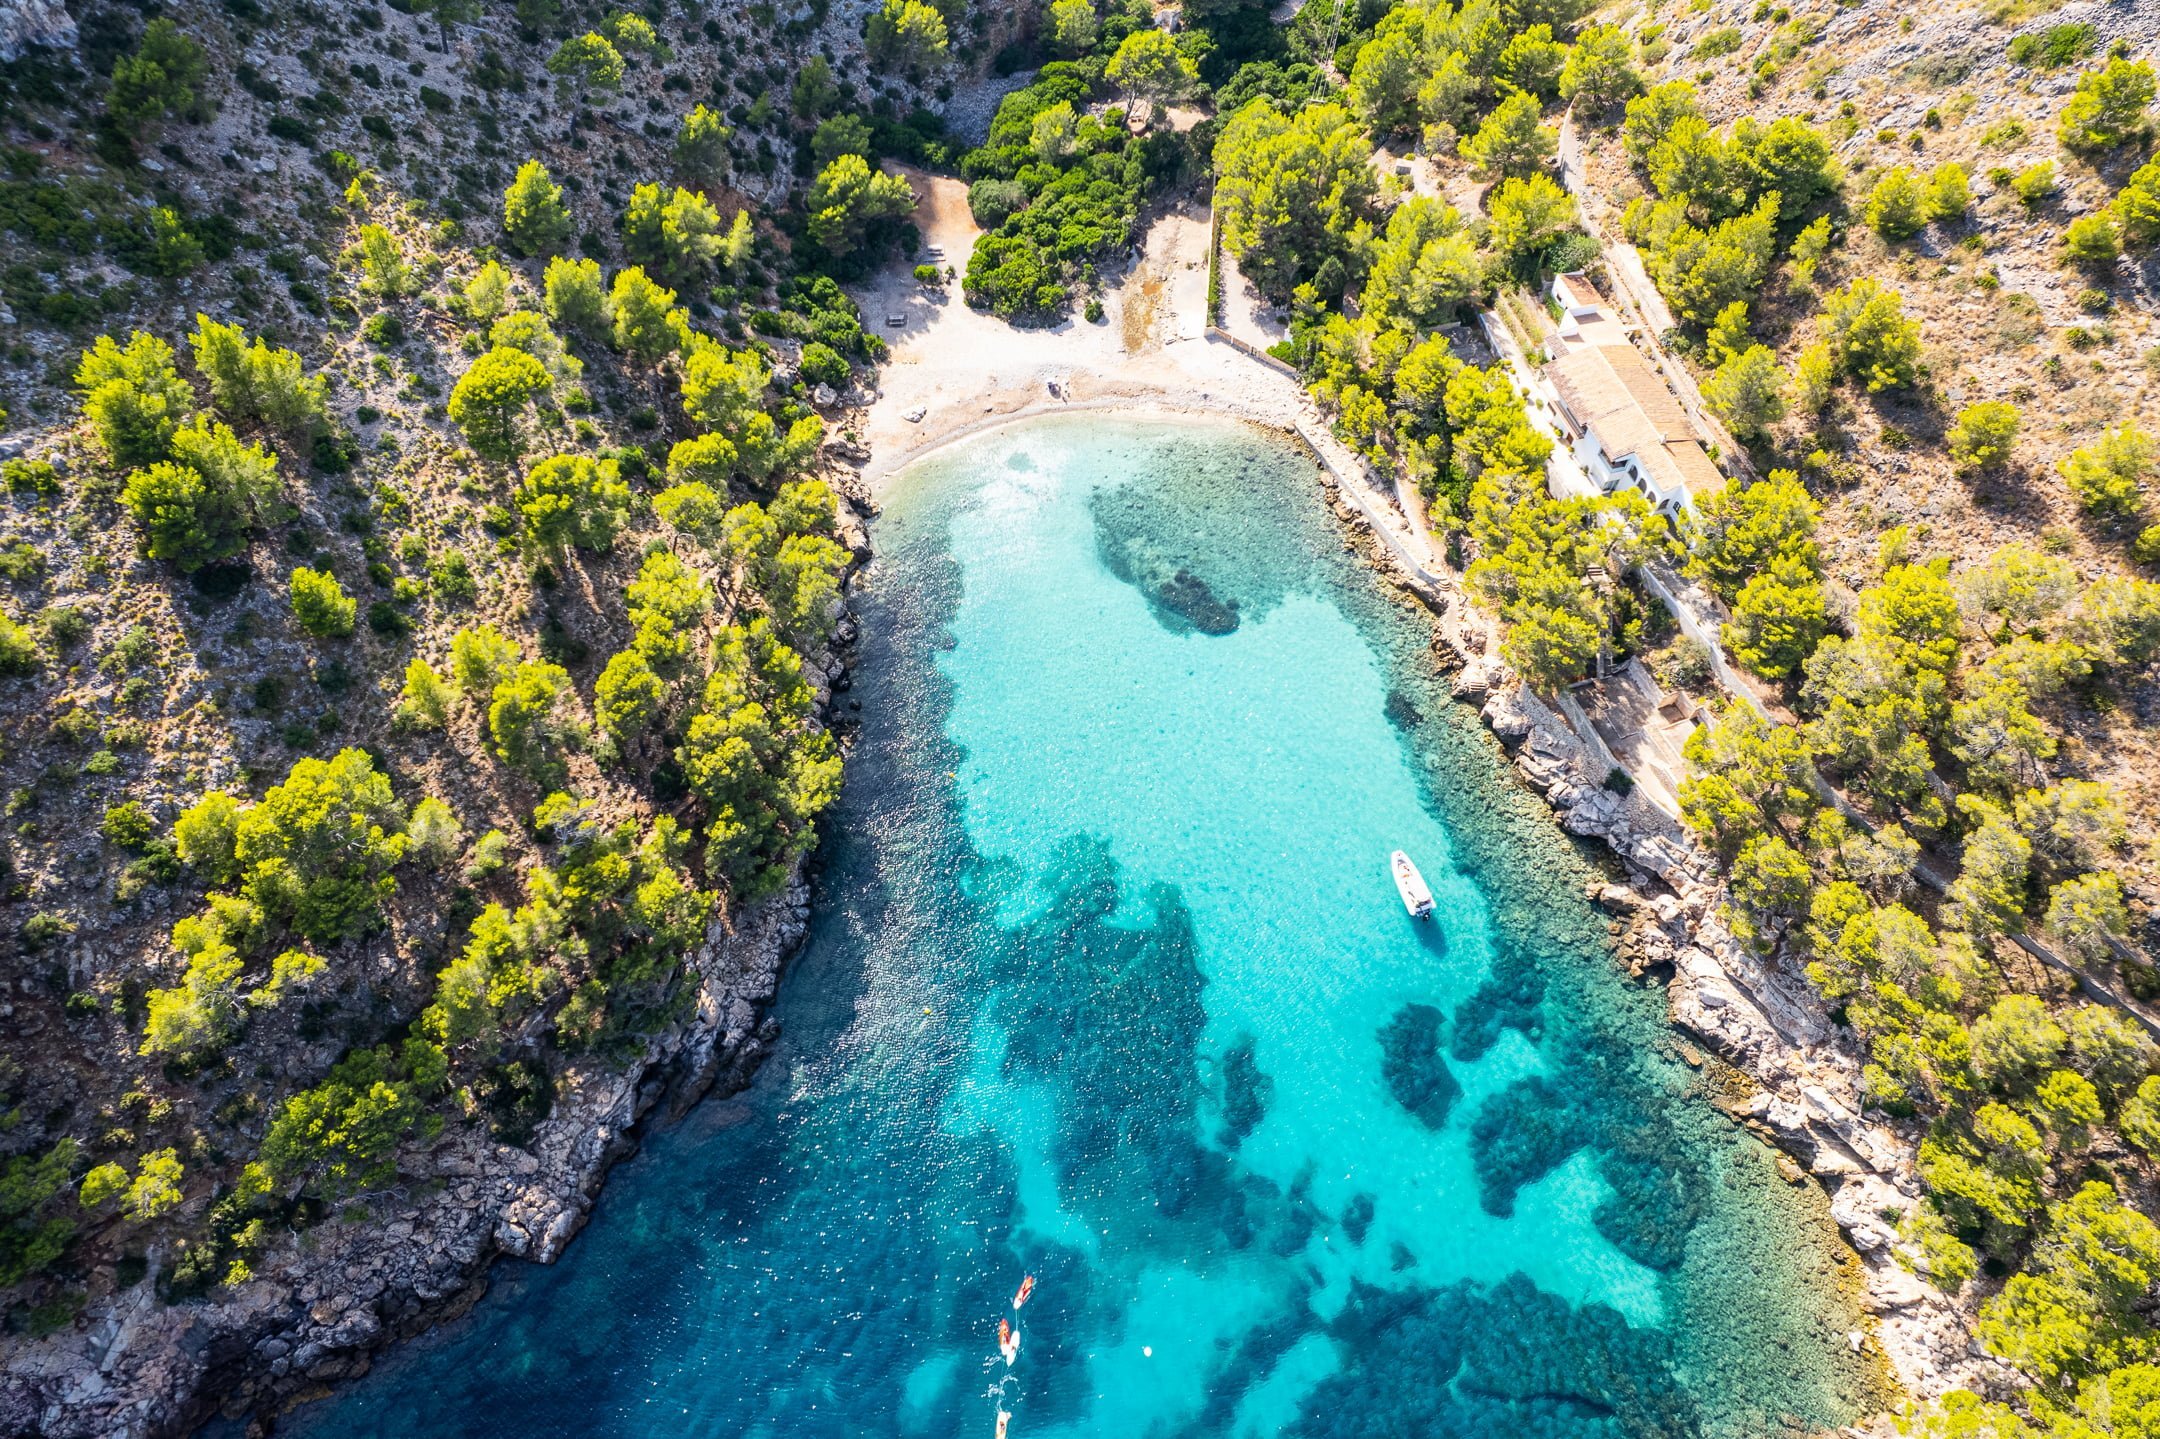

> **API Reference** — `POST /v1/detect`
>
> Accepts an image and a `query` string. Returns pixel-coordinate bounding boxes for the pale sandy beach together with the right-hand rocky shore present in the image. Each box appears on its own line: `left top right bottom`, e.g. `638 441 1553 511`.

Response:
825 177 2011 1426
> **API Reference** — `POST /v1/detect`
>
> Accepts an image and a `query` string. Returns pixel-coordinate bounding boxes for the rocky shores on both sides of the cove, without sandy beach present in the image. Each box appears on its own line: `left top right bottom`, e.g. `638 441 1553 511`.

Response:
0 386 1978 1439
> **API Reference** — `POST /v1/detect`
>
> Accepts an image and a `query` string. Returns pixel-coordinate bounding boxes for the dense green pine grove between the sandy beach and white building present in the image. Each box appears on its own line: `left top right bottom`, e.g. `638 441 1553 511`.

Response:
1214 4 1674 685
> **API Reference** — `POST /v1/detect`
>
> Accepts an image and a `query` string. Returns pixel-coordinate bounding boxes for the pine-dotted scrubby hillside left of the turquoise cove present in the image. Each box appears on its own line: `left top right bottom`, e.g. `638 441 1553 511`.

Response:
0 4 894 1327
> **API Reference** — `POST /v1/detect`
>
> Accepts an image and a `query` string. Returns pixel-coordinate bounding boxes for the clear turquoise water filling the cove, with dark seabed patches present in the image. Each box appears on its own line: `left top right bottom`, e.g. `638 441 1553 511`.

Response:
292 415 1871 1439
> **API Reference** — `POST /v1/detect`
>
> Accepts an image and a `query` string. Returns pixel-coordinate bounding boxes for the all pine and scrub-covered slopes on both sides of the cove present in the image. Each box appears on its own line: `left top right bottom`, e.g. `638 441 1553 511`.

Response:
0 0 2160 1437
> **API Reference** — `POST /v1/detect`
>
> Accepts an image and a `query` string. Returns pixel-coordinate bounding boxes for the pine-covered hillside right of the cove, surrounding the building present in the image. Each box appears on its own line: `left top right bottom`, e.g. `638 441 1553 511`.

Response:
1214 0 2160 1435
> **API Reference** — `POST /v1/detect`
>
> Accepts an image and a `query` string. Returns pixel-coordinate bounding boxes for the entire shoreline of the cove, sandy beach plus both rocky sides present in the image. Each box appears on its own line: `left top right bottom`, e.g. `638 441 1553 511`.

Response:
0 181 1996 1439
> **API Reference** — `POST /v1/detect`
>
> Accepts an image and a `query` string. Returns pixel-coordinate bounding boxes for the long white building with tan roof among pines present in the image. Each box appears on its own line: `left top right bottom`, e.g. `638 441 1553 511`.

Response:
1544 272 1726 516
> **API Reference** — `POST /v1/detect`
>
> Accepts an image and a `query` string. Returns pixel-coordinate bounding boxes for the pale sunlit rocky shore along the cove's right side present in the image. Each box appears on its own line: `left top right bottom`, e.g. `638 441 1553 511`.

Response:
1296 460 2020 1408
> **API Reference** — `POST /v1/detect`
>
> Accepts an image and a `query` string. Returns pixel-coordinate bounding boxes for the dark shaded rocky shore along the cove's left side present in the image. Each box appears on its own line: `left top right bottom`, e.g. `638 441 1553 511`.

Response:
0 503 868 1439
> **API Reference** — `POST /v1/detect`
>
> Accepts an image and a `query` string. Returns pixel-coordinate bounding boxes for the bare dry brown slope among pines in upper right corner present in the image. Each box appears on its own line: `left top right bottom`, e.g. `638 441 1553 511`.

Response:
1585 0 2160 890
